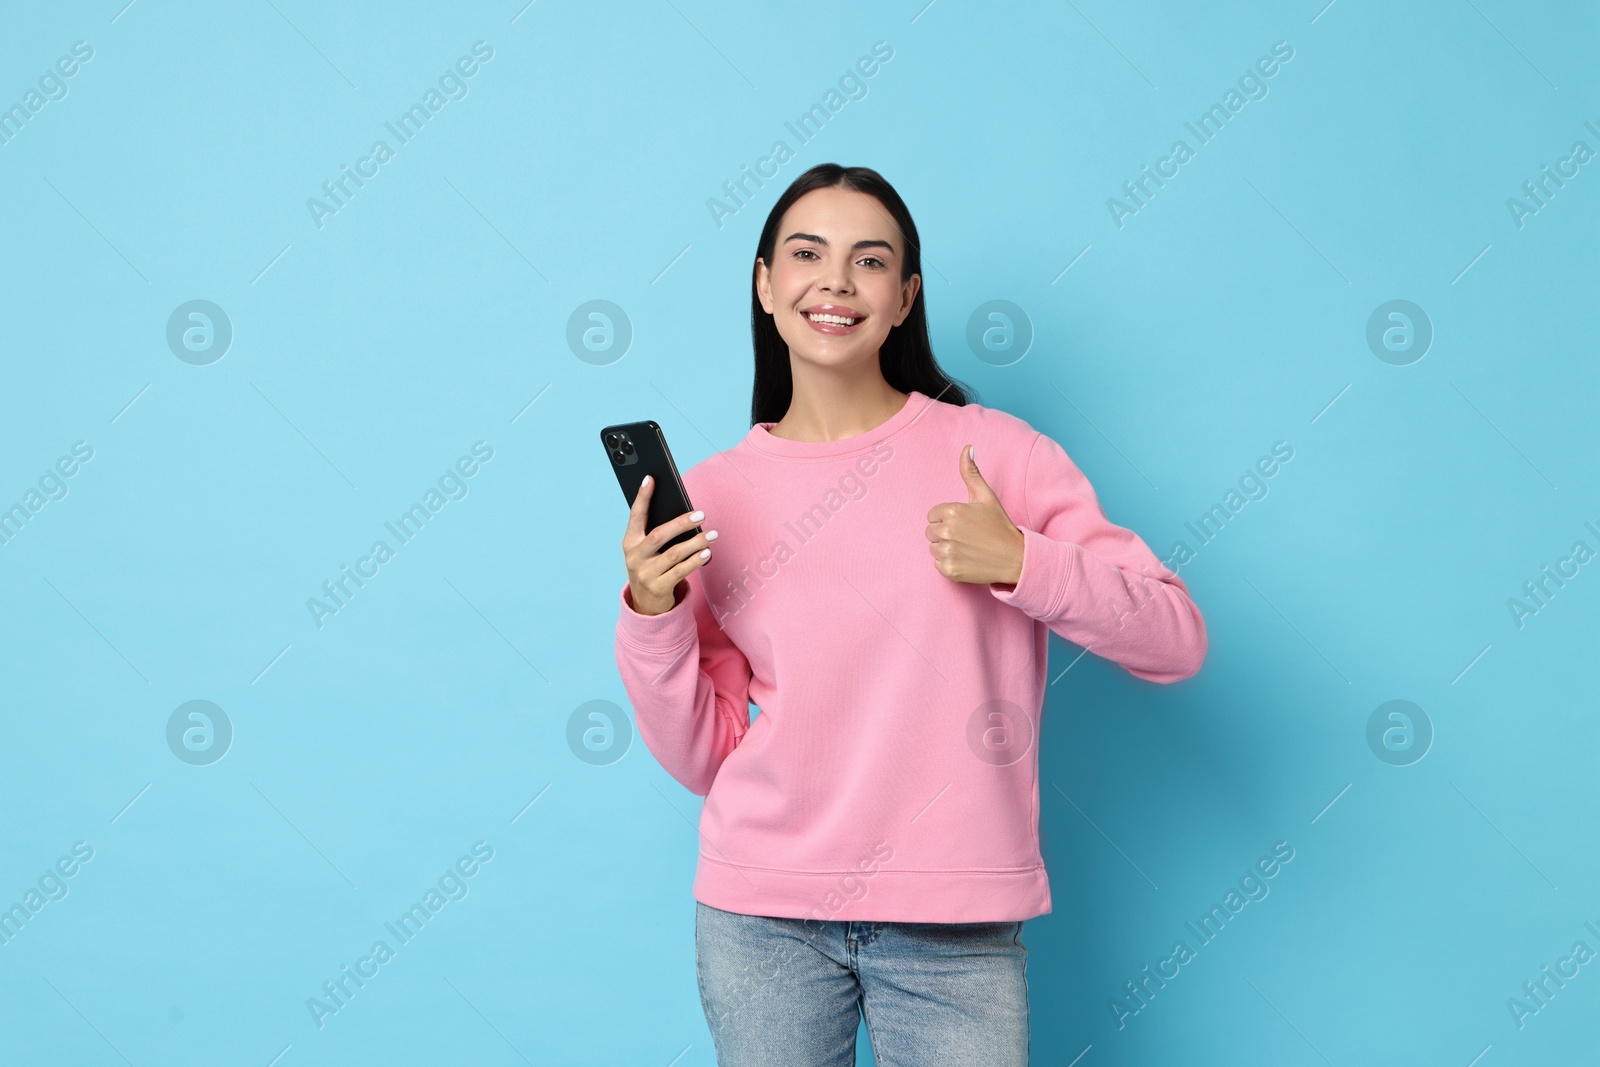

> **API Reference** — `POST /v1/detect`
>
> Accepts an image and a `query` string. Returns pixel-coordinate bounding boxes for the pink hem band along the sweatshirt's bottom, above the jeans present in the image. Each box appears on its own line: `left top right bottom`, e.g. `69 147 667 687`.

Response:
694 853 1051 923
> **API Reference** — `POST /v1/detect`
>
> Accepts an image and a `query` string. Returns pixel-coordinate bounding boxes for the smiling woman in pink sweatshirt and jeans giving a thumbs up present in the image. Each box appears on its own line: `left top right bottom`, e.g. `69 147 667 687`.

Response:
616 163 1206 1067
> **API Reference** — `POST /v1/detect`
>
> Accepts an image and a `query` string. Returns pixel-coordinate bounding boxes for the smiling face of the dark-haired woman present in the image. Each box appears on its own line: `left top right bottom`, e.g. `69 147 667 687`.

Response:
755 186 922 375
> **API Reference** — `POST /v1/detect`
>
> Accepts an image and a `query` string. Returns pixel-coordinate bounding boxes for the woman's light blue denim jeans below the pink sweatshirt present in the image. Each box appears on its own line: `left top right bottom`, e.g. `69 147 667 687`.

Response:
694 901 1029 1067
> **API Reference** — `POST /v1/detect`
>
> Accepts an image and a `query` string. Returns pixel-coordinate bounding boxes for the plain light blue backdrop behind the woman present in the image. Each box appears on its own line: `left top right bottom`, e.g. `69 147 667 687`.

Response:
0 0 1600 1067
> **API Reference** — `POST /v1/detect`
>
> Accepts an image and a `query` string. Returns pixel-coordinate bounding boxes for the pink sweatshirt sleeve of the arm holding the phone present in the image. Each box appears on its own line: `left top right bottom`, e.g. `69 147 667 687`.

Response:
616 571 750 797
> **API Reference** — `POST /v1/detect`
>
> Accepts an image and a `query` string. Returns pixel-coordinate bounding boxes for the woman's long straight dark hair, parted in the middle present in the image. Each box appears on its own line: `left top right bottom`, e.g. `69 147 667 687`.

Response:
750 163 971 427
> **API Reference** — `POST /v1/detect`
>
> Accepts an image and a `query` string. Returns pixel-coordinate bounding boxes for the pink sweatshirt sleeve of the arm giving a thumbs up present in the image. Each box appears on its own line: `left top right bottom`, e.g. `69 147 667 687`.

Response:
989 434 1206 683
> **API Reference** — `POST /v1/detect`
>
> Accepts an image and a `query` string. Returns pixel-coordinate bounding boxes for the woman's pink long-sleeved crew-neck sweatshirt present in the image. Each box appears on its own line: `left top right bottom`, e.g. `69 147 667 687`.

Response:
616 390 1206 923
